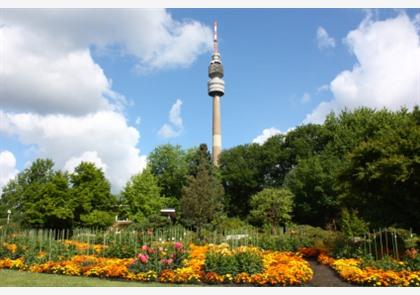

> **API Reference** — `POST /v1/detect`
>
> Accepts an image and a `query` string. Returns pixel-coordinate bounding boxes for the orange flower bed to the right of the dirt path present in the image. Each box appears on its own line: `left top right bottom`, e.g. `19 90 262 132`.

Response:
318 253 420 287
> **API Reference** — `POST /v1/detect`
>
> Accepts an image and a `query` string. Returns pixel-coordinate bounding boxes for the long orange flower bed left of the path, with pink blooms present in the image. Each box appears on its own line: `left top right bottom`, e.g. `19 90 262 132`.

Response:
0 242 313 286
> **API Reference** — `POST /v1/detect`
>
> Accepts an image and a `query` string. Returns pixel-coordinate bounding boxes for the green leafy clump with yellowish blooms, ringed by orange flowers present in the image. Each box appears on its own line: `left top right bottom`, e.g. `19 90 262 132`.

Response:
204 251 263 275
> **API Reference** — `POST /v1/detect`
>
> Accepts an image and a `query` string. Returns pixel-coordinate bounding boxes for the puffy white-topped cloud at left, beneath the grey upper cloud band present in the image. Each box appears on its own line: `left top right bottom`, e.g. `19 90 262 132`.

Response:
0 26 118 115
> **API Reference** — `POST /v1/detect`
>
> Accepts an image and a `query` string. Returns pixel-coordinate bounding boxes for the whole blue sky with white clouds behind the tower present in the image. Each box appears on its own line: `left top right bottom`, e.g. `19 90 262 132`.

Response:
0 8 420 192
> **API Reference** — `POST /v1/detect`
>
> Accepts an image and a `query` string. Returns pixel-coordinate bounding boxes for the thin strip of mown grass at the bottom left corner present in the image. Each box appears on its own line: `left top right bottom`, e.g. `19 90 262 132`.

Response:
0 269 191 287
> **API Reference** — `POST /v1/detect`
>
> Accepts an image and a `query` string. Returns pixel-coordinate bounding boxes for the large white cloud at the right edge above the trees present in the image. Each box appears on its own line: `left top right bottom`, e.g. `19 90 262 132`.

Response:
304 14 420 123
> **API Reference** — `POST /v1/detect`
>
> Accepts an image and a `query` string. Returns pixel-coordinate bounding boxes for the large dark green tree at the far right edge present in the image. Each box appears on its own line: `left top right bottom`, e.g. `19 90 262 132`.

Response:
338 107 420 231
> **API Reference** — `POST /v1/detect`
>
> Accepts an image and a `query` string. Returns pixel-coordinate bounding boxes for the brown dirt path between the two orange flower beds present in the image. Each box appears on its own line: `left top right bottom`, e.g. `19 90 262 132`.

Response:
306 260 353 287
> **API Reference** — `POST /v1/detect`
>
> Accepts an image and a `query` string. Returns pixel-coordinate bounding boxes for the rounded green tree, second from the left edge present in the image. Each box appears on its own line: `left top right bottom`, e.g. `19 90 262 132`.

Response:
70 162 116 227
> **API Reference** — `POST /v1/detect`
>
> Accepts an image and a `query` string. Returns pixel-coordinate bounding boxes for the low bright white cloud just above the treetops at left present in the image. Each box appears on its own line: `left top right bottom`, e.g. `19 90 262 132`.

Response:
0 111 146 192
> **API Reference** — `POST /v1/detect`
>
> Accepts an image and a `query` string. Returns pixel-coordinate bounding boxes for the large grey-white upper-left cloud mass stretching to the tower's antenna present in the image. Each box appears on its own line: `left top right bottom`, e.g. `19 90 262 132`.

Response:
0 9 211 115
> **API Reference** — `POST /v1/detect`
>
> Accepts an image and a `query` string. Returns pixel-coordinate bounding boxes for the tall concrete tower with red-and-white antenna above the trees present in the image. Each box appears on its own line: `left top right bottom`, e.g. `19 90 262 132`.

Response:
207 21 225 166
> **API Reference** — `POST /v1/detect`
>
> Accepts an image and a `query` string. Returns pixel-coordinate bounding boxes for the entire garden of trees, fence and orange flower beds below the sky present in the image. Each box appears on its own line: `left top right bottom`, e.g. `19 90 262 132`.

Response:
0 107 420 287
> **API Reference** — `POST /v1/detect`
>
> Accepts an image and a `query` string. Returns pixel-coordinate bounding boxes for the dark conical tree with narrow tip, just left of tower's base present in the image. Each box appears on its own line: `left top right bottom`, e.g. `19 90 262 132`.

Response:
180 145 224 229
